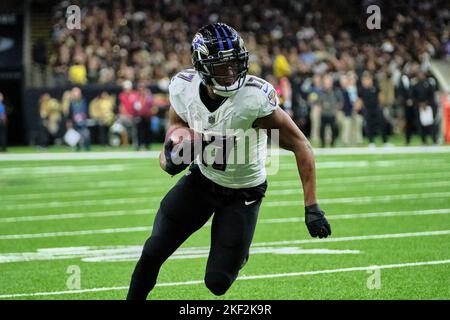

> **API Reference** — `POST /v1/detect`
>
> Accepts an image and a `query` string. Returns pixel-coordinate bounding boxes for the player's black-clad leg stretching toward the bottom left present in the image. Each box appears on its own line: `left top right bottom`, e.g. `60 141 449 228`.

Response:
127 173 213 300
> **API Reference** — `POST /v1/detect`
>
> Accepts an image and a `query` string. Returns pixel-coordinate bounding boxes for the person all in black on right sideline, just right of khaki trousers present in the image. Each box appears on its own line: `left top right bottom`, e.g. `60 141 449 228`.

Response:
358 72 388 147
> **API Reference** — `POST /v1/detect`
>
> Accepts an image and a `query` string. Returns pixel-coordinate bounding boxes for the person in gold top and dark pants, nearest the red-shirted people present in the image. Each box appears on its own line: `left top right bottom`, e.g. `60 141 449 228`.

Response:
89 91 115 146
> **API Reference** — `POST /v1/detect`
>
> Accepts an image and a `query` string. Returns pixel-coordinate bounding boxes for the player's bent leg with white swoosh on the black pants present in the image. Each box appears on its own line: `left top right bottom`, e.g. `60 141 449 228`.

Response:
205 191 262 295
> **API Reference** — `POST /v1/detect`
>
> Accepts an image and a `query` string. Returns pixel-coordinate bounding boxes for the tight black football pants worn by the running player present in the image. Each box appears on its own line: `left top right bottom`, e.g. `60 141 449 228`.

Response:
127 166 267 300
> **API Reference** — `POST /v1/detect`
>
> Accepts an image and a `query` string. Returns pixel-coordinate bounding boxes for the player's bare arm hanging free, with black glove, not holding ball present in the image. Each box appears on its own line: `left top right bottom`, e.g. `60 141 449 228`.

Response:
254 107 331 238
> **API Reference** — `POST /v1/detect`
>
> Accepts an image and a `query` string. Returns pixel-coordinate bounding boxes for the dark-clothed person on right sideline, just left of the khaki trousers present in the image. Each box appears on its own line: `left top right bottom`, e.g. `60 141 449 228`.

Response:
316 75 342 148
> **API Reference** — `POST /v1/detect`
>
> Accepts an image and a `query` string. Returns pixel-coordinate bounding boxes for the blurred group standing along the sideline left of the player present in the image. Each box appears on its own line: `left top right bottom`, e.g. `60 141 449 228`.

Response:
37 80 168 151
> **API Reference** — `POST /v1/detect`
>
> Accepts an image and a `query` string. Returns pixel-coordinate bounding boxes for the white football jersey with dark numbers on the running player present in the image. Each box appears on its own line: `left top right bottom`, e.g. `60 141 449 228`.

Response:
169 69 278 189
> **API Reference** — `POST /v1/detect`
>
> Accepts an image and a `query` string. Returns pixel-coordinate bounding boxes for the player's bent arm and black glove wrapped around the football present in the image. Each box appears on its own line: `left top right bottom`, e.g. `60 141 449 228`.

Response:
159 107 189 175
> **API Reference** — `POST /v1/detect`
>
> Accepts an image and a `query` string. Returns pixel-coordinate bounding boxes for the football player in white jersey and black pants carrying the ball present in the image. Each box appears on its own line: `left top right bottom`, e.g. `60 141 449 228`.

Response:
127 23 331 299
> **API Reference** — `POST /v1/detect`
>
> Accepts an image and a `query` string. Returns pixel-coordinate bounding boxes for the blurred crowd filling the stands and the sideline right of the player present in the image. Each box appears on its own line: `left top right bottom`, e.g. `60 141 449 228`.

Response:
29 0 450 146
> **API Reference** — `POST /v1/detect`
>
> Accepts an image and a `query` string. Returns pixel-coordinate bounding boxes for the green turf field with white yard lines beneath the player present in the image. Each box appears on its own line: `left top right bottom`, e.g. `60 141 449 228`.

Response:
0 151 450 300
